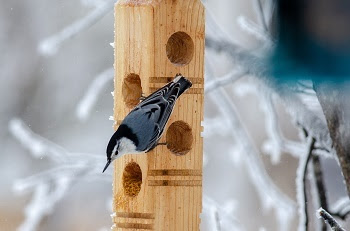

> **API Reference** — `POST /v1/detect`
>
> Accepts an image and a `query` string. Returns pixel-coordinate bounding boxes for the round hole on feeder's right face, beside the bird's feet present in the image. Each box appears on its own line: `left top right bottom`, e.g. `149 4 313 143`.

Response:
166 121 193 155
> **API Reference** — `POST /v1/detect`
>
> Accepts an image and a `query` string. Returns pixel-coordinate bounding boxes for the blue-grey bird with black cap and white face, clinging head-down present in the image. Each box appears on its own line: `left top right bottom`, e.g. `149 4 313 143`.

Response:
102 74 192 172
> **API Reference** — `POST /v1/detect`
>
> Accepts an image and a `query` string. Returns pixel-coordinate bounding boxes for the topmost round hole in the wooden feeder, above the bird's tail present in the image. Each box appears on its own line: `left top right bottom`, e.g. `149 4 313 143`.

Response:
166 31 194 65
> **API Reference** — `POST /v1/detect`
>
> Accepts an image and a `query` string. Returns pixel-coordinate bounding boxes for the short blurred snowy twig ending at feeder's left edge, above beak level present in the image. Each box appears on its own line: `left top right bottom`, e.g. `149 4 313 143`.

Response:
75 68 114 121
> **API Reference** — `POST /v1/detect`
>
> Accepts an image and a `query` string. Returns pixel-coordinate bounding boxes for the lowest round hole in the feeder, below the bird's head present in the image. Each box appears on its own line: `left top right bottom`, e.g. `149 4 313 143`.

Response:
123 162 142 197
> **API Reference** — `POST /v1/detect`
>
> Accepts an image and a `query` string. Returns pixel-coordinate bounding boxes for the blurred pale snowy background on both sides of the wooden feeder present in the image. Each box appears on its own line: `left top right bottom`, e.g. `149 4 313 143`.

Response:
0 0 350 231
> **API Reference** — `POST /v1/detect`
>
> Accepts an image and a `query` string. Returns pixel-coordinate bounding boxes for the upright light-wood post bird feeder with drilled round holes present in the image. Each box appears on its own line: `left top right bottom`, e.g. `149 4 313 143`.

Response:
113 0 205 231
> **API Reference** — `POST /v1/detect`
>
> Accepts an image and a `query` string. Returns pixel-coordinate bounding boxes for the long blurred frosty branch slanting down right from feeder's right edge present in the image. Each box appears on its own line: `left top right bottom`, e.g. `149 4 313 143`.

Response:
207 60 295 230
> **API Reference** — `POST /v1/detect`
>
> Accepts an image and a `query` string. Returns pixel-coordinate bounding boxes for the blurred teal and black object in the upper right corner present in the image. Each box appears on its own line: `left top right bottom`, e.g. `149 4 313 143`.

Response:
270 0 350 82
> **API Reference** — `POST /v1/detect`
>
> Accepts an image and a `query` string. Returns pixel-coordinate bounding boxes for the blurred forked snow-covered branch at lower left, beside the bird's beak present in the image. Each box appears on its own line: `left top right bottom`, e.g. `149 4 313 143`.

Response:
9 118 111 231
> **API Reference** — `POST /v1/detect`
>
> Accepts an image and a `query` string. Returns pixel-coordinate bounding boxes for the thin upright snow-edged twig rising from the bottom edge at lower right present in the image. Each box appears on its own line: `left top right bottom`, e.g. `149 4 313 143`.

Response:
296 137 316 231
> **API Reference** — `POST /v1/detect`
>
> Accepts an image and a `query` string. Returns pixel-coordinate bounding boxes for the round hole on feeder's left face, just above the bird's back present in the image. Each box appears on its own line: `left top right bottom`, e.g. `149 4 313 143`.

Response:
122 73 142 108
